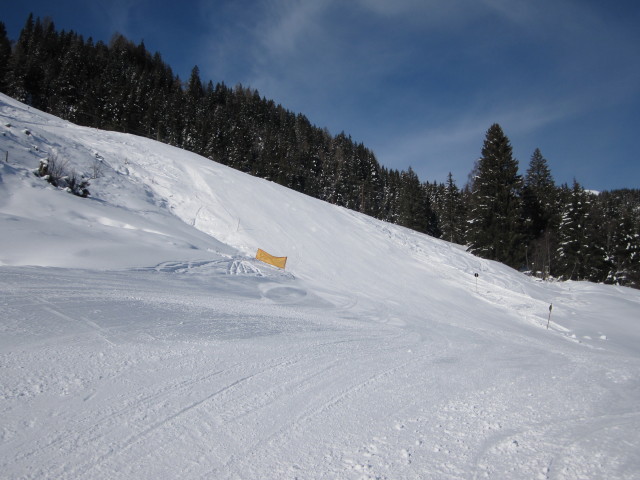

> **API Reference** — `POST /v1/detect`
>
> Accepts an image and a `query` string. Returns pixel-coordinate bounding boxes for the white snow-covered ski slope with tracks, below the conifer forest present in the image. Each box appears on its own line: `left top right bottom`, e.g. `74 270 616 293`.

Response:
0 96 640 480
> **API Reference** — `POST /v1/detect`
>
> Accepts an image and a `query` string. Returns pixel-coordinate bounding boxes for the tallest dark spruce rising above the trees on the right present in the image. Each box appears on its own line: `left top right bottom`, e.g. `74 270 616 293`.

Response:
467 123 524 268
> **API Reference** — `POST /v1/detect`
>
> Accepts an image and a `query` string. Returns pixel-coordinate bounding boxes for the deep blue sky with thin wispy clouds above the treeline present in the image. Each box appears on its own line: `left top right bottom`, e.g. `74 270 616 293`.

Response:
0 0 640 190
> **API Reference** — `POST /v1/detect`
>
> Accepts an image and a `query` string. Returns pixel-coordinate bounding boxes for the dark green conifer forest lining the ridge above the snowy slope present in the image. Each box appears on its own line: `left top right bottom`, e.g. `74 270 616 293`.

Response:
0 15 640 288
